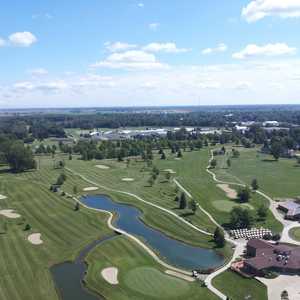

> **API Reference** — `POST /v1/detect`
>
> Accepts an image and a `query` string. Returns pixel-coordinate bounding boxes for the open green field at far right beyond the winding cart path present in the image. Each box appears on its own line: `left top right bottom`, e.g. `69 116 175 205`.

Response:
216 147 300 198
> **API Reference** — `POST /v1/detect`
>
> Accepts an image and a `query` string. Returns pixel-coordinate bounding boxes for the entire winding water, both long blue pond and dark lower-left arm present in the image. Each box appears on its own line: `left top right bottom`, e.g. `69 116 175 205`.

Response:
51 195 224 300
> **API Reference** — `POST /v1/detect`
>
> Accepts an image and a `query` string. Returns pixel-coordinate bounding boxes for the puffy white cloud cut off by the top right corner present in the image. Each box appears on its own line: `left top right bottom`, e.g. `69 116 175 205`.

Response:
242 0 300 22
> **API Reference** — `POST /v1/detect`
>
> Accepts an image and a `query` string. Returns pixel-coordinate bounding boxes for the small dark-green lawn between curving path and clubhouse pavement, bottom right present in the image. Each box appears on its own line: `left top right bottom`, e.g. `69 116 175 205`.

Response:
213 270 268 300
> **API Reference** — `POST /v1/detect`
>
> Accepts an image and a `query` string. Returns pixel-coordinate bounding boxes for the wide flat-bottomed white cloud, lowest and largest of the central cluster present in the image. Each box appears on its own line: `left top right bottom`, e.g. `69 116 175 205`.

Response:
91 50 167 69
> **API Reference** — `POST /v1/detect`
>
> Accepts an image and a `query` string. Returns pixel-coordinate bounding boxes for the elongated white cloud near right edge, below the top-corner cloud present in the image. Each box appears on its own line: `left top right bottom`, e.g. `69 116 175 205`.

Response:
232 43 297 59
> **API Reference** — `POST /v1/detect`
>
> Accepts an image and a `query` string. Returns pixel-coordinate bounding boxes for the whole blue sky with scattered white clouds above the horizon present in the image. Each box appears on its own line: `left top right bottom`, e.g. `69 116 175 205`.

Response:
0 0 300 108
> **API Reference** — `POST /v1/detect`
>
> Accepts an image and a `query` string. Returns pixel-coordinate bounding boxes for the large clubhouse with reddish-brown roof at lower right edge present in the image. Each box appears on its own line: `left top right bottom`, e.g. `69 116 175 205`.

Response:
242 239 300 276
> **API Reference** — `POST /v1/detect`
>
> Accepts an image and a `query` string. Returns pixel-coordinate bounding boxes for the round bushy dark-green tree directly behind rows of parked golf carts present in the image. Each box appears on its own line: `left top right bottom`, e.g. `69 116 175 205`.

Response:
229 206 254 229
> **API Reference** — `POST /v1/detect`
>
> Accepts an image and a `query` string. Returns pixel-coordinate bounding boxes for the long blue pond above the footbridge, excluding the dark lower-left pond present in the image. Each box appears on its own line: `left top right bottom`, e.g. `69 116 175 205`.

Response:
81 195 224 270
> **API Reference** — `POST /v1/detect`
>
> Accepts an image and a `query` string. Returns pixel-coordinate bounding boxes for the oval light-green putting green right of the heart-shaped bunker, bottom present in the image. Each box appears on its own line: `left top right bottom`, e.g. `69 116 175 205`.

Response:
124 267 189 299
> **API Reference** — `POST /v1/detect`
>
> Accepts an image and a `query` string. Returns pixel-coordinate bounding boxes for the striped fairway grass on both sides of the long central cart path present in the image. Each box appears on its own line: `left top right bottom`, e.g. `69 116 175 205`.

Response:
67 152 232 258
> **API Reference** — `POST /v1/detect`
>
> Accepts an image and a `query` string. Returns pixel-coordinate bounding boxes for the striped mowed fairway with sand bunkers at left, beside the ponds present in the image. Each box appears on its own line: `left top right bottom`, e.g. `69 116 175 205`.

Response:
0 158 110 300
